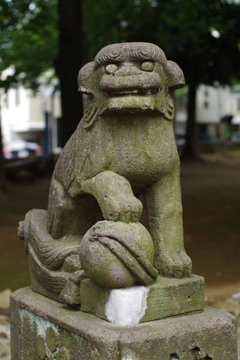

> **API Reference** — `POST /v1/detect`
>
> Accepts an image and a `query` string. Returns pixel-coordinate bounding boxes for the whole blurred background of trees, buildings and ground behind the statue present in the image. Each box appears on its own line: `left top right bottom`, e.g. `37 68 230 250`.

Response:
0 0 240 352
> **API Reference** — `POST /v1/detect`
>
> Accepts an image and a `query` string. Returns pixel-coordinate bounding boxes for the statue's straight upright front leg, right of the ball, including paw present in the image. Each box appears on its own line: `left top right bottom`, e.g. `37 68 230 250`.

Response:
145 171 191 278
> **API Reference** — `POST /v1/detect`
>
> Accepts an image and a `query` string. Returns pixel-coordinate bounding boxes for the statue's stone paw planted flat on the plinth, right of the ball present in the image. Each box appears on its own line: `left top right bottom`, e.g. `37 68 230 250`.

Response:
159 251 192 279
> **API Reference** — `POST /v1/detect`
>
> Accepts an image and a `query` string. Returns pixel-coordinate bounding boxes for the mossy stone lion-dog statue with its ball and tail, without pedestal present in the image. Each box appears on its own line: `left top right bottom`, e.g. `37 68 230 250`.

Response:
19 42 191 304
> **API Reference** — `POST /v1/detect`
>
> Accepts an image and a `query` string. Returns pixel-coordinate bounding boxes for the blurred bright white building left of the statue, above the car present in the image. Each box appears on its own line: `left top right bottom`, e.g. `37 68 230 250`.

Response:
1 86 61 157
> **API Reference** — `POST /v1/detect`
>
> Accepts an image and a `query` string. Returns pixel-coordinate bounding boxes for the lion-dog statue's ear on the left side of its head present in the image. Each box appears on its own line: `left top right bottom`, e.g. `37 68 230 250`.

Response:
78 62 95 95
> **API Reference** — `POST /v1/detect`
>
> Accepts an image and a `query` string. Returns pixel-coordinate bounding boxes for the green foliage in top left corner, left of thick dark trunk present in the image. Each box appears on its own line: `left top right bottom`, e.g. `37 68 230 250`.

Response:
0 0 58 89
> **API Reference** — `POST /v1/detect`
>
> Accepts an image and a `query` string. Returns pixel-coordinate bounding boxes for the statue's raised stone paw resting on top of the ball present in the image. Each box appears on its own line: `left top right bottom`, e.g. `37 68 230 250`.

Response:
103 195 143 223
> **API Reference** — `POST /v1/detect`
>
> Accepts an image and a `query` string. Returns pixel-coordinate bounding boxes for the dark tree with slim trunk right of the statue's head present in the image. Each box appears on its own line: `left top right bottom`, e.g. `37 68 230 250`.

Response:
160 0 240 159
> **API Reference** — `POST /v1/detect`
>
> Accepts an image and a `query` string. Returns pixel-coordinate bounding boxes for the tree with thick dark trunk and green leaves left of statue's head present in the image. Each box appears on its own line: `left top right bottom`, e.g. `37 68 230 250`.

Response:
0 0 86 145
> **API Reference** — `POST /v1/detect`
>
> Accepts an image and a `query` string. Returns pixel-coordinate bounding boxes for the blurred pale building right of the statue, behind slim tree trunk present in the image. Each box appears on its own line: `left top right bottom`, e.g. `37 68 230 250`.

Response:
175 84 240 141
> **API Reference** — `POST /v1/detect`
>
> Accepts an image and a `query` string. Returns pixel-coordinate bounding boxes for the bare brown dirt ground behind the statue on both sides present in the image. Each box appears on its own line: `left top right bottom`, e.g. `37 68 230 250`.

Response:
0 151 240 302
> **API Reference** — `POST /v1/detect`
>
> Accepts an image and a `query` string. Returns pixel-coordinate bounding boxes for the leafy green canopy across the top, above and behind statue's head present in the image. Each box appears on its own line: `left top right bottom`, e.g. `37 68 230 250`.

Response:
0 0 240 88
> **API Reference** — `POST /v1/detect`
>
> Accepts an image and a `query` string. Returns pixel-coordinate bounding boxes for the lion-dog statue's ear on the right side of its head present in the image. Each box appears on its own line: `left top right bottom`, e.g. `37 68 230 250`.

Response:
163 60 185 91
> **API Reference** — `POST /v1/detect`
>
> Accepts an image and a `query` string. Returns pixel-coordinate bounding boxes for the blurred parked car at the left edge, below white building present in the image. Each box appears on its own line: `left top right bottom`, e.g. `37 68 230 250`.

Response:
3 140 43 159
